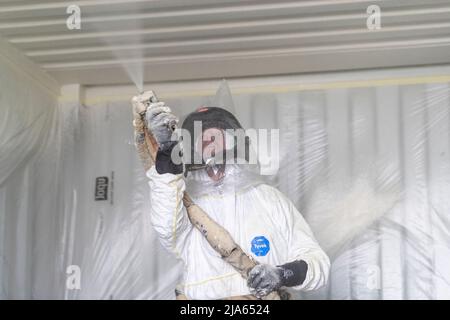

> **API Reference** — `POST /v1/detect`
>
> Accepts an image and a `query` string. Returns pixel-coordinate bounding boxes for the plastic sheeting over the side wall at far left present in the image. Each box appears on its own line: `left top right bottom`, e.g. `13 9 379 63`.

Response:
0 57 62 299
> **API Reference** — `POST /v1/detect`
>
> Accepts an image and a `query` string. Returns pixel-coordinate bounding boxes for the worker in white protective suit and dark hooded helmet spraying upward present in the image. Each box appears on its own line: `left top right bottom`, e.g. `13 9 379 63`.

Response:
146 102 330 299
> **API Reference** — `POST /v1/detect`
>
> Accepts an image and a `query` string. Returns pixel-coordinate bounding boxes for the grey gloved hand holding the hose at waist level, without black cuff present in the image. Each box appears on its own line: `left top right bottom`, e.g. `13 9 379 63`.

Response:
247 264 283 298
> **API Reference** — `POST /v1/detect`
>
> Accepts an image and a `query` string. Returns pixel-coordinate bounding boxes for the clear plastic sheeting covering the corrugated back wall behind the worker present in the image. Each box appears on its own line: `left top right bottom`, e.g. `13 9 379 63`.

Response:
0 74 450 299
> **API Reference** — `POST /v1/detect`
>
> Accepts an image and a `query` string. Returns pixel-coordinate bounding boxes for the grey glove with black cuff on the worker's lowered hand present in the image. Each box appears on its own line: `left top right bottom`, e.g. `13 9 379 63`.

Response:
247 260 308 298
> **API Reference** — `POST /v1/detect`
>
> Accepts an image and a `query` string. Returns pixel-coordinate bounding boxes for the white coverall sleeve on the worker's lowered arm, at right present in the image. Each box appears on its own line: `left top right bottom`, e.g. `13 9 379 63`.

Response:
279 192 330 291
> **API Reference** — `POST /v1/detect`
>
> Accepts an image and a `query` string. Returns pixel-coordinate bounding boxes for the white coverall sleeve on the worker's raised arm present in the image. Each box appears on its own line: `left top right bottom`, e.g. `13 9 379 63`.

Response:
147 166 192 257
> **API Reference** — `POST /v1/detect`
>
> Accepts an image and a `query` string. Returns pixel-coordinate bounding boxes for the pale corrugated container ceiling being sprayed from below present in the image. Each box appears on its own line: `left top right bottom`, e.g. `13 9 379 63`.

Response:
0 0 450 85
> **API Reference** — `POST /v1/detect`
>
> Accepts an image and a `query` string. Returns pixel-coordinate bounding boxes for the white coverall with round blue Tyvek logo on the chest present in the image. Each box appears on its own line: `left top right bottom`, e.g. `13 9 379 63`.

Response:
147 166 330 299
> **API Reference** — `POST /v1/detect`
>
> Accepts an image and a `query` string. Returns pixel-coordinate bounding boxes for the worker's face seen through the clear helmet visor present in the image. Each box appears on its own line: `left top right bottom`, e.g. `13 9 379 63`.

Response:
195 128 225 181
